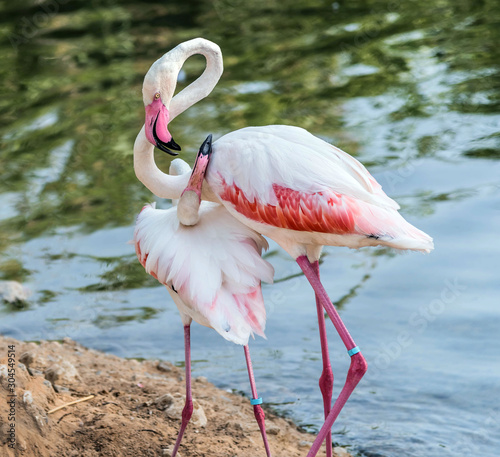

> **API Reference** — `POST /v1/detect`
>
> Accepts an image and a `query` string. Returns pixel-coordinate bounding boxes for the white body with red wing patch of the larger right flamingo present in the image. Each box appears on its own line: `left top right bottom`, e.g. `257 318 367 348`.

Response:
206 125 433 260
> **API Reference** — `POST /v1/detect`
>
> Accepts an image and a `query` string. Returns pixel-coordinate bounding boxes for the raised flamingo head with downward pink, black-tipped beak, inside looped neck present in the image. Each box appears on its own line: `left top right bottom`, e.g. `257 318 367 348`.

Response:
142 59 181 156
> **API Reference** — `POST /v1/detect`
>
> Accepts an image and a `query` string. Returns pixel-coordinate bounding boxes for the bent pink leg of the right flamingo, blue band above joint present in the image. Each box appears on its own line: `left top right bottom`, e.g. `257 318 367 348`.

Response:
297 256 367 457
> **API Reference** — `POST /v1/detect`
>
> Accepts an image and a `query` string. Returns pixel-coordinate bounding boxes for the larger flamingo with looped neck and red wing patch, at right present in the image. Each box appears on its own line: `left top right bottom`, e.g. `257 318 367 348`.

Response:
134 38 434 457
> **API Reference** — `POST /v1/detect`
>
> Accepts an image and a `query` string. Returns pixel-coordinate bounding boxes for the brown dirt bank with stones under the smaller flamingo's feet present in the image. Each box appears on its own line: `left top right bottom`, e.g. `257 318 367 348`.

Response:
0 335 350 457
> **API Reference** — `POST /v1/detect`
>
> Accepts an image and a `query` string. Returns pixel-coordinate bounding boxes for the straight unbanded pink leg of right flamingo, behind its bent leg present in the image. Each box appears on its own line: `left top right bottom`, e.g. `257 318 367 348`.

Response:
312 260 333 457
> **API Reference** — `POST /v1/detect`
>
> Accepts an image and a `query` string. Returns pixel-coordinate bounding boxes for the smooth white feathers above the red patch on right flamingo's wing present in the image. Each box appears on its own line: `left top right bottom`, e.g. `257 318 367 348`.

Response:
207 125 399 209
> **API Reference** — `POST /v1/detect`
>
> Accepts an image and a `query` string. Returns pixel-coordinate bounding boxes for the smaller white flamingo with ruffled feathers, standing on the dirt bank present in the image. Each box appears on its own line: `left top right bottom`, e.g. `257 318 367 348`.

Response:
133 136 274 457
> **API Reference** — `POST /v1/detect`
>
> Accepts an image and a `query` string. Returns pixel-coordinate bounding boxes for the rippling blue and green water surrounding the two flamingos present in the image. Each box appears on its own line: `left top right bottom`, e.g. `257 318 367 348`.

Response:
0 0 500 457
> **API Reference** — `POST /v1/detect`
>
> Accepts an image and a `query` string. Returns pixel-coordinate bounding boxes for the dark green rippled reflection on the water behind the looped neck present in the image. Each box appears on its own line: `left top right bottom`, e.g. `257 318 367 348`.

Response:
0 0 500 302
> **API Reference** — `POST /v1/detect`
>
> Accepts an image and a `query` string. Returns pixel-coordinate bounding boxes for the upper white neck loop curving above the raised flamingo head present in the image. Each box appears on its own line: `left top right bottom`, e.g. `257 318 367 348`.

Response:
167 38 224 121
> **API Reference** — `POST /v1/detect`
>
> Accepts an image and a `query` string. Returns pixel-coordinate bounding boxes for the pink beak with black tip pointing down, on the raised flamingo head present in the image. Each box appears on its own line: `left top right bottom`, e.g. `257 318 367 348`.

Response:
146 97 181 156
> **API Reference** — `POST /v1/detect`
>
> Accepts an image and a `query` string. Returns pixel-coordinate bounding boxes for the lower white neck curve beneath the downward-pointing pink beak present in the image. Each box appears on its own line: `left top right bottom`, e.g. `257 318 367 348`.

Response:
134 126 191 199
